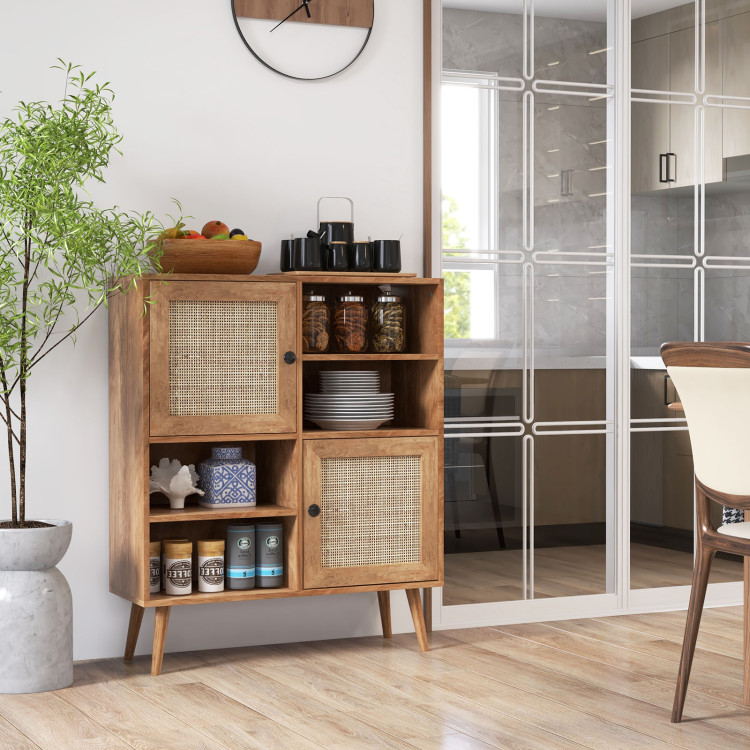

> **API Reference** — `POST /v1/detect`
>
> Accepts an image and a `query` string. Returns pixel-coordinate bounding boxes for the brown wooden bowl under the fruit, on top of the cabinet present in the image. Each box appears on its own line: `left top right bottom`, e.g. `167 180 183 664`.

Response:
154 240 261 274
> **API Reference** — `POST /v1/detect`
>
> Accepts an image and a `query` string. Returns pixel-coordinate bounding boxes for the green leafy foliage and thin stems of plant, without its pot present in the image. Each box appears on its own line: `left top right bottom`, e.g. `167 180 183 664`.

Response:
0 60 181 526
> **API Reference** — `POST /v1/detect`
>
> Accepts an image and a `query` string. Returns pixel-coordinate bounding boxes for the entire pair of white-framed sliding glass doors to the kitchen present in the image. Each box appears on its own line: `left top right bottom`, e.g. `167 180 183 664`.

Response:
440 0 750 624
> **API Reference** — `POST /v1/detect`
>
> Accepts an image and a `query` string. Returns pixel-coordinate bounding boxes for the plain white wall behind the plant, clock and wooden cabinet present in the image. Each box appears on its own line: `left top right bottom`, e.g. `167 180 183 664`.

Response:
0 0 422 659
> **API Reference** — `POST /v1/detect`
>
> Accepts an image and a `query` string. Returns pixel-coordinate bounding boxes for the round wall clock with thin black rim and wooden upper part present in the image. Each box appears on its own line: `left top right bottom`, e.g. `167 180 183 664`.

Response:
232 0 375 81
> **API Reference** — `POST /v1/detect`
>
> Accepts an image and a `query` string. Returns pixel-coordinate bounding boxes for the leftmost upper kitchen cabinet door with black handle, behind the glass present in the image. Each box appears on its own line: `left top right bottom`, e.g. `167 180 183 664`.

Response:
631 35 670 193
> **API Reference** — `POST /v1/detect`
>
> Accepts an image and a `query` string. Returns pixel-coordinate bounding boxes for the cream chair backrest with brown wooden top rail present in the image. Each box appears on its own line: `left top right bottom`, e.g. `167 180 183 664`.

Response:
661 342 750 495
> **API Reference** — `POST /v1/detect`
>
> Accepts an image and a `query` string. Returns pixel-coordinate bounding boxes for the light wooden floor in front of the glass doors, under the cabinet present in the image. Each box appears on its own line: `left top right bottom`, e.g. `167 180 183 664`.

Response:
0 607 750 750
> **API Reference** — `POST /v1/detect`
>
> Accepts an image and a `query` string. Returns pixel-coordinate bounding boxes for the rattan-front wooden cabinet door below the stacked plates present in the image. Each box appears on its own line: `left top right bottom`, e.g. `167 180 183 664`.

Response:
303 438 439 589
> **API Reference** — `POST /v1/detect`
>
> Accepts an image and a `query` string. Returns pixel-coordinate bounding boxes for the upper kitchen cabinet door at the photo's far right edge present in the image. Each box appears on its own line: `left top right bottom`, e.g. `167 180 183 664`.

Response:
720 13 750 157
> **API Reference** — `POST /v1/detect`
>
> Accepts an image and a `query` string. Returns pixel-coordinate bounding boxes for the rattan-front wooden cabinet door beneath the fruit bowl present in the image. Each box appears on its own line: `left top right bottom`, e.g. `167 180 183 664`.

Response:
149 280 297 436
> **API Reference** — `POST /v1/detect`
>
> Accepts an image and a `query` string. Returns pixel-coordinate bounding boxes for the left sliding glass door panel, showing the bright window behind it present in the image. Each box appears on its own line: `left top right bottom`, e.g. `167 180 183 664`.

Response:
441 0 614 611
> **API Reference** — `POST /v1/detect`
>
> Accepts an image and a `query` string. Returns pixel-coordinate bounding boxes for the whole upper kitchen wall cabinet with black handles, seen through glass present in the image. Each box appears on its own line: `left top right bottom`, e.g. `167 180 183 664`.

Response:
632 3 750 193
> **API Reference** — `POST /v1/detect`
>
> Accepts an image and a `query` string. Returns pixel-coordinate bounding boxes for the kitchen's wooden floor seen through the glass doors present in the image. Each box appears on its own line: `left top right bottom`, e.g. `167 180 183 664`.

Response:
443 544 742 605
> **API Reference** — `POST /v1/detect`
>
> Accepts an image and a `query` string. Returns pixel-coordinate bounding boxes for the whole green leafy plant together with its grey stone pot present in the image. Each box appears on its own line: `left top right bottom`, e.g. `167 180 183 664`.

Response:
0 61 173 693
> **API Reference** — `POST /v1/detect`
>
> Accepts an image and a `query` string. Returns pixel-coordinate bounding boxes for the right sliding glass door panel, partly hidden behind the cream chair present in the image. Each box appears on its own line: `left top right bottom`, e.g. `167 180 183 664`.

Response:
630 0 750 604
